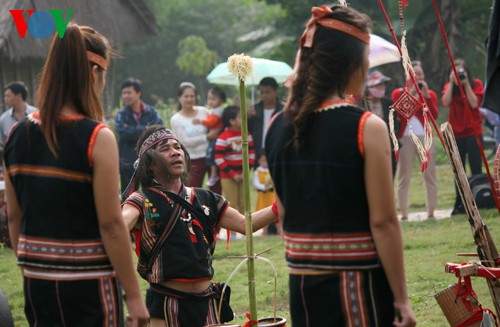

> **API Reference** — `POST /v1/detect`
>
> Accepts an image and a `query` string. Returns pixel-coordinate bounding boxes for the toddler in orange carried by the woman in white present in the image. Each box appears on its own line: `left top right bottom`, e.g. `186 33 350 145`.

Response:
193 86 226 186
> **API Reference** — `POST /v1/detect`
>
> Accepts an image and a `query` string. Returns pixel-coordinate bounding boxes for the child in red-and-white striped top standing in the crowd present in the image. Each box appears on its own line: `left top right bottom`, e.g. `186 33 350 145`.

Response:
215 106 255 240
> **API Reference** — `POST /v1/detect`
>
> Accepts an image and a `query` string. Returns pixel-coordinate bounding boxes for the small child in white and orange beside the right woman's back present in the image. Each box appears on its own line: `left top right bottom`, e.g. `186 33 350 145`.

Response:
253 151 281 235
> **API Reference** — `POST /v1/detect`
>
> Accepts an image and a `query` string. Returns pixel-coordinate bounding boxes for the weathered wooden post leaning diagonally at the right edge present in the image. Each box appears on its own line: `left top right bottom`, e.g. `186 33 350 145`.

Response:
441 123 500 319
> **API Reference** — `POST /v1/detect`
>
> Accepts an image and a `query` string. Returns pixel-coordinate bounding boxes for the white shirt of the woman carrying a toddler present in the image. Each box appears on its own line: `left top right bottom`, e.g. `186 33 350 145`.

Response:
170 106 209 159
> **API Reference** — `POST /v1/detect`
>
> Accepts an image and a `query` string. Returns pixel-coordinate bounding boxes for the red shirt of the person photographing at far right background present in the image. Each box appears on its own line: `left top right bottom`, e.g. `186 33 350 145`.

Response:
443 78 484 138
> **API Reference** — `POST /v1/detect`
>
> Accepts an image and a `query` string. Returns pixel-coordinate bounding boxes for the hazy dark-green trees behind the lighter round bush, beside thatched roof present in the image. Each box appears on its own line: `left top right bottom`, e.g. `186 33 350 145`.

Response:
116 0 284 109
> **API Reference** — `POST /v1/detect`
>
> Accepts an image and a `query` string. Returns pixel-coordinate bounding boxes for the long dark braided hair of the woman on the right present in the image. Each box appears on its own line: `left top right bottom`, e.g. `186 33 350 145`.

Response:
285 5 371 149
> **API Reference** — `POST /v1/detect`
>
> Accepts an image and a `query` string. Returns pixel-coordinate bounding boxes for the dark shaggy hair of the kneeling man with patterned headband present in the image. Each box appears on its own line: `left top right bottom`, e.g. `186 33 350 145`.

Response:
135 125 191 188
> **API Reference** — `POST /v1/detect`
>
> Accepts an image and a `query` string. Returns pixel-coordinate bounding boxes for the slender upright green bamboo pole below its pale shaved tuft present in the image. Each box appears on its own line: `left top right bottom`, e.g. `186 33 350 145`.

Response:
239 79 257 321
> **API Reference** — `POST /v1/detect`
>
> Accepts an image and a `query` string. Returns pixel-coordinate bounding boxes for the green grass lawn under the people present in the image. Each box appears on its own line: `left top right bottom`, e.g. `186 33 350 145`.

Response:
0 158 500 327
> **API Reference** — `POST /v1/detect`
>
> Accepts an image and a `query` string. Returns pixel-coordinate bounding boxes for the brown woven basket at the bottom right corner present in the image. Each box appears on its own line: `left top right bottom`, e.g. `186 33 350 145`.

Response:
434 282 481 327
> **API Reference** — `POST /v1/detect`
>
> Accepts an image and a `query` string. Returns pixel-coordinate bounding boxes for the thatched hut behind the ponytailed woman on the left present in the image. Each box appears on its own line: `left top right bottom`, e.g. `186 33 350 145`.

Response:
0 0 158 112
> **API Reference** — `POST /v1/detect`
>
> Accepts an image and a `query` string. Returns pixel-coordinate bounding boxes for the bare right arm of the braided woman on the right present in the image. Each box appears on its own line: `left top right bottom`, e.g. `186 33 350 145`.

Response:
363 115 415 326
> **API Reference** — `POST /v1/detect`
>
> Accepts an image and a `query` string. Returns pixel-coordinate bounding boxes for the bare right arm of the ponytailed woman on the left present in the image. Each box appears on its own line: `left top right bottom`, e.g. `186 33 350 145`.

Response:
92 128 149 326
